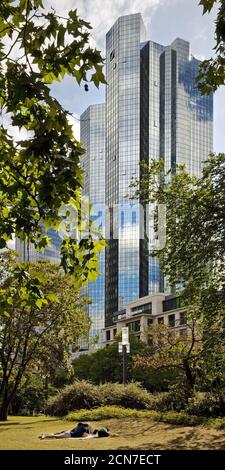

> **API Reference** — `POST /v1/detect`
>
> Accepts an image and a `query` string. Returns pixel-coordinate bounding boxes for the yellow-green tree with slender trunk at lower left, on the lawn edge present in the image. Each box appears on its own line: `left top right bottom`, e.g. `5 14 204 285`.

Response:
0 255 90 420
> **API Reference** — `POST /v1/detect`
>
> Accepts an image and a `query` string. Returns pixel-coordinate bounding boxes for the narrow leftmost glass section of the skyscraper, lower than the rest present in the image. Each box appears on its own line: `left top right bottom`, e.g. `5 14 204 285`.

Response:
80 104 105 350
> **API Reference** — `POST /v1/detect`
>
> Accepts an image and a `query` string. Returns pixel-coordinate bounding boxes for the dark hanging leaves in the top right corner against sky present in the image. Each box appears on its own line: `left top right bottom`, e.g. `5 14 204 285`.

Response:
197 0 225 94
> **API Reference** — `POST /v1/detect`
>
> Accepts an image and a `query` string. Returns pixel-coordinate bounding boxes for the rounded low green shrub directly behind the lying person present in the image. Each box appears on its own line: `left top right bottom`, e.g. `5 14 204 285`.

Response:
45 380 102 416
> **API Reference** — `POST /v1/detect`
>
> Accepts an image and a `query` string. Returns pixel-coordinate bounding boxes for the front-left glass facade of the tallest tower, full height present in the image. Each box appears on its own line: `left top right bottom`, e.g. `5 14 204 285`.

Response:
106 14 148 324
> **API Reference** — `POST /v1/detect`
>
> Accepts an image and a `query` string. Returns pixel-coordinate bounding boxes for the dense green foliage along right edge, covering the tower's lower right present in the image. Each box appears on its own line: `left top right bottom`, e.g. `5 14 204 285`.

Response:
132 154 225 392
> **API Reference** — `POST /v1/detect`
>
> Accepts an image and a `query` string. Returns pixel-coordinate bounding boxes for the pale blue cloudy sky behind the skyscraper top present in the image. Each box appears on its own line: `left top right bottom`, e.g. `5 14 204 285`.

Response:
44 0 225 152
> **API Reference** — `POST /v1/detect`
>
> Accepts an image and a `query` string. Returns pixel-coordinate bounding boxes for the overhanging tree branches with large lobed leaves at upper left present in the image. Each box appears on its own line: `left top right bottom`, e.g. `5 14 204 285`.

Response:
0 0 106 306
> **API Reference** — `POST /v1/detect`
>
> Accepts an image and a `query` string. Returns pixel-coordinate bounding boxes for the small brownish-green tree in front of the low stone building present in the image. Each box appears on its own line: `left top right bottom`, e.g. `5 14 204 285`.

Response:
134 313 202 396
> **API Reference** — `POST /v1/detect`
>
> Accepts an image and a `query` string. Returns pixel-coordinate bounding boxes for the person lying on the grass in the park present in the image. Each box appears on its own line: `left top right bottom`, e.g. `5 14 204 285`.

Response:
39 423 109 439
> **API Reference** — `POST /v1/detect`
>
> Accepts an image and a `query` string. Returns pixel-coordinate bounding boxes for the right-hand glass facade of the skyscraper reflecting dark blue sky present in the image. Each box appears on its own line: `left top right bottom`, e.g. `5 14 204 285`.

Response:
160 39 213 176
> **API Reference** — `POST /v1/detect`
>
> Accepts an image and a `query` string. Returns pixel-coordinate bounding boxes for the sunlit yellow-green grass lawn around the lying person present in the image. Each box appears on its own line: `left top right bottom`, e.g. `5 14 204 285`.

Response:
0 416 225 450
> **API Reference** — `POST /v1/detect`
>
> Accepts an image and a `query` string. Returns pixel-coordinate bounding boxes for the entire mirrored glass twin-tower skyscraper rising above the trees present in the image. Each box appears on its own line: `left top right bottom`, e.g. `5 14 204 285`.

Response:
81 13 213 348
